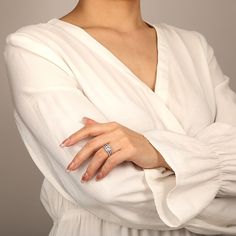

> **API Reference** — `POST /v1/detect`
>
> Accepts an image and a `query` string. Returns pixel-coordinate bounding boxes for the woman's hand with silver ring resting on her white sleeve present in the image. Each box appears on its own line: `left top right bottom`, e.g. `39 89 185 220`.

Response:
60 117 171 182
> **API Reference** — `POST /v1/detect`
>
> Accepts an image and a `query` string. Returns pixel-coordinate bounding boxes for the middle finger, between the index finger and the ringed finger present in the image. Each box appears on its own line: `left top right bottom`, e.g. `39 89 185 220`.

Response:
67 132 114 170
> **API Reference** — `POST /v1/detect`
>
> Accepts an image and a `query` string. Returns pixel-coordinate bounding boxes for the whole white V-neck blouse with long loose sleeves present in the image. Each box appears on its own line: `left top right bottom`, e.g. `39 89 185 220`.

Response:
4 18 236 236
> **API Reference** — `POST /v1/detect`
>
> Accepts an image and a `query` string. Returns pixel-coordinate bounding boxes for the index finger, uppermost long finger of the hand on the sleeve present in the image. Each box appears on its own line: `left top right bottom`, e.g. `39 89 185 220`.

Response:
62 122 116 146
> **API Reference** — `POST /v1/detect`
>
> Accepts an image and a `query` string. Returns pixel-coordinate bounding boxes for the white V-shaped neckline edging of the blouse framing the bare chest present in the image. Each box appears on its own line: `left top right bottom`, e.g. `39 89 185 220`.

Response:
48 18 169 103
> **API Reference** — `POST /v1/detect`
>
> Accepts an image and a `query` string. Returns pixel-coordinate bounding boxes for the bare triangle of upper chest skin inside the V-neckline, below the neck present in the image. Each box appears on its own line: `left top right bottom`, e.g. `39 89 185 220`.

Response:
79 25 158 91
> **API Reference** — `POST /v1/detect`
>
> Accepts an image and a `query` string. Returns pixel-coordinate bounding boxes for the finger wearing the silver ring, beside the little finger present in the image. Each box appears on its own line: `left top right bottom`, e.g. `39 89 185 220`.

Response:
82 141 120 181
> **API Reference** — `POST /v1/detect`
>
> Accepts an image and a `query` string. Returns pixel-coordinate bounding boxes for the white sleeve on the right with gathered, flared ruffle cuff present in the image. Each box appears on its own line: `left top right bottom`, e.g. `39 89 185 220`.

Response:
140 33 236 227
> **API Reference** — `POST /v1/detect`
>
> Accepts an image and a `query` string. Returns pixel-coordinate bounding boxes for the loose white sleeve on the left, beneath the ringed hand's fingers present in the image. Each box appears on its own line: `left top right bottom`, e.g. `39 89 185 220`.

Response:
4 32 171 229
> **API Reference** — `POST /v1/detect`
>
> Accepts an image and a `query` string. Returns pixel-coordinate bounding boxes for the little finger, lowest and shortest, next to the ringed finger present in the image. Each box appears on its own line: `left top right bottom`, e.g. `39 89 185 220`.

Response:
96 149 127 180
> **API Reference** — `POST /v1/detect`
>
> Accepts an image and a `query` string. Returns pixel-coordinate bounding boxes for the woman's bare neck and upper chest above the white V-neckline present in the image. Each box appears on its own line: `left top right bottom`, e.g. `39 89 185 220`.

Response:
60 0 158 91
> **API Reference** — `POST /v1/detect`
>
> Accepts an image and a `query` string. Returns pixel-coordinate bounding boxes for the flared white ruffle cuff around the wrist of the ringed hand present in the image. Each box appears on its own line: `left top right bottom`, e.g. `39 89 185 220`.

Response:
143 127 221 227
